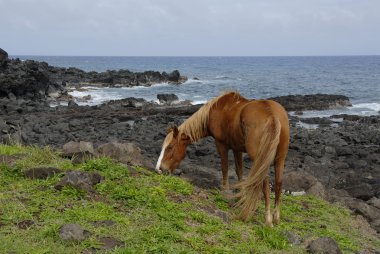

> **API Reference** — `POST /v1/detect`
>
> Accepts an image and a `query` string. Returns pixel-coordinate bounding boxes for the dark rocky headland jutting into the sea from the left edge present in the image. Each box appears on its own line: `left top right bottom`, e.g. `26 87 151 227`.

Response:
0 49 187 100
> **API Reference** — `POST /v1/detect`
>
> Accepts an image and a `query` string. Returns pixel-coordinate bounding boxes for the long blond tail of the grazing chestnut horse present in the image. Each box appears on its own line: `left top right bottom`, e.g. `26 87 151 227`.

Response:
235 119 281 220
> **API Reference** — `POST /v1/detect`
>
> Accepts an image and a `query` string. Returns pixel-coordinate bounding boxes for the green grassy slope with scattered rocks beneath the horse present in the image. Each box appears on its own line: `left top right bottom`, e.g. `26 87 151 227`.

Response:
0 145 380 253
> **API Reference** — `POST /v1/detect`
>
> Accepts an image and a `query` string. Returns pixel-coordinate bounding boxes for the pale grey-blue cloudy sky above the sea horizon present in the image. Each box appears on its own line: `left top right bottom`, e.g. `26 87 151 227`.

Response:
0 0 380 56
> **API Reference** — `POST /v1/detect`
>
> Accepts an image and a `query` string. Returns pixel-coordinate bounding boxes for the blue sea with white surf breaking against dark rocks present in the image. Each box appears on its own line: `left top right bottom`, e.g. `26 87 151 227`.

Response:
14 56 380 116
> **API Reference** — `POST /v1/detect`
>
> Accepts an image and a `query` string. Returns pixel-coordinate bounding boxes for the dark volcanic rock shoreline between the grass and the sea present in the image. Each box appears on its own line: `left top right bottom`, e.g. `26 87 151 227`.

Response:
0 48 380 232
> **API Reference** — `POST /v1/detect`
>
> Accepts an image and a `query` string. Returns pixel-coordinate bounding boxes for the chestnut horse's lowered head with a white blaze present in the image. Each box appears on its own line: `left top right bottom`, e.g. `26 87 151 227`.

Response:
156 127 190 174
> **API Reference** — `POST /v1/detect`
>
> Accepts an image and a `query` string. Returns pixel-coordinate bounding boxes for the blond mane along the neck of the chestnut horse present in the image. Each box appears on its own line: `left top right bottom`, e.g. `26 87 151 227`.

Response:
178 91 241 142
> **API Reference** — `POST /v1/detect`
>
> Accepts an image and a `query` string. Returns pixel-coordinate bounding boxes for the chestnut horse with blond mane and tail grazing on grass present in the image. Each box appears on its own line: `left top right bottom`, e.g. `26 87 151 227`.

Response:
156 92 289 226
